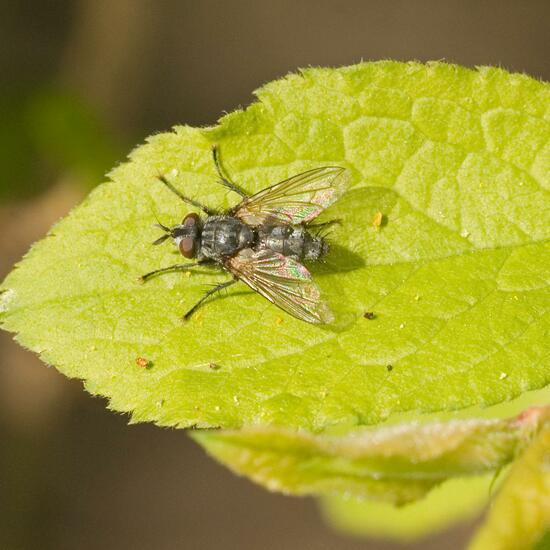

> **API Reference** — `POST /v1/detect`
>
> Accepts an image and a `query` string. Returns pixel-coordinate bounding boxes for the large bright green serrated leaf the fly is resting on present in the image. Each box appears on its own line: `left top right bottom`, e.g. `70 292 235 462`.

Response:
0 61 550 431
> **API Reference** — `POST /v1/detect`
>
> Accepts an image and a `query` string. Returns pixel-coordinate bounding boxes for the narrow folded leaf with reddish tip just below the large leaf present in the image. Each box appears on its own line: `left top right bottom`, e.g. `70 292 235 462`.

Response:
193 407 550 504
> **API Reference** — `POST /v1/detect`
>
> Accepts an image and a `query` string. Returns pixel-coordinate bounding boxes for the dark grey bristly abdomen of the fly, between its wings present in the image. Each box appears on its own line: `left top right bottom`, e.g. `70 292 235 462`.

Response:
258 225 328 260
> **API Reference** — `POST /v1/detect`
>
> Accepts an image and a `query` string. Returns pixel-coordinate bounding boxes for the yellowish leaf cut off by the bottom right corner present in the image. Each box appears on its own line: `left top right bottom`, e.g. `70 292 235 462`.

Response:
470 421 550 550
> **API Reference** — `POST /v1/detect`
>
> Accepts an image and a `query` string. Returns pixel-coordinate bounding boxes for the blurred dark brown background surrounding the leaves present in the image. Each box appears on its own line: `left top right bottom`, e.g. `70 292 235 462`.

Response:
0 0 550 550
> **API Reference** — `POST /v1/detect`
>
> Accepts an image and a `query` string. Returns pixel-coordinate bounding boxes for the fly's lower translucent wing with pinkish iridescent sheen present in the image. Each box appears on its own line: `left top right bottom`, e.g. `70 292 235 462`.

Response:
225 248 334 323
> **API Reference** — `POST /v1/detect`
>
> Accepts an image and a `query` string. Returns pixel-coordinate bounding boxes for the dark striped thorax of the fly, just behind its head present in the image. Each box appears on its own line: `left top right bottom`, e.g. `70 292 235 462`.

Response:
200 216 254 260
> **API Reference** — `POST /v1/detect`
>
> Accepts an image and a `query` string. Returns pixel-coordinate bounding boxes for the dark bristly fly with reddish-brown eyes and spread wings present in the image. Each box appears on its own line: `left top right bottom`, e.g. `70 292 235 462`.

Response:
141 147 348 323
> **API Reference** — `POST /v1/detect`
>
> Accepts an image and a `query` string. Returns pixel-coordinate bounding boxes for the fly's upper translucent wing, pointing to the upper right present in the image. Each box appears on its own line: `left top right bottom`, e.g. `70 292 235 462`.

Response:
235 166 348 227
